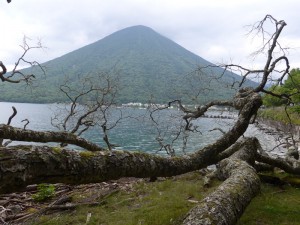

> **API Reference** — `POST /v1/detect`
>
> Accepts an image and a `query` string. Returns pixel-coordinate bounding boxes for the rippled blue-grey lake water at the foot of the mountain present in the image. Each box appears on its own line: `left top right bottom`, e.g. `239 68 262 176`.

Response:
0 102 275 154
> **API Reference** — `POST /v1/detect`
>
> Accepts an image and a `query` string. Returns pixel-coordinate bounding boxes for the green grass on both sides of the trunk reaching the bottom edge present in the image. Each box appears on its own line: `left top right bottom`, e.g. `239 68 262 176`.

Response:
25 172 300 225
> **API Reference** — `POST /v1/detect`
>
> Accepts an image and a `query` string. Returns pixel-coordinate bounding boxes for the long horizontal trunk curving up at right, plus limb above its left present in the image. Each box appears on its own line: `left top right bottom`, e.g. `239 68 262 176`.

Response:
0 92 262 192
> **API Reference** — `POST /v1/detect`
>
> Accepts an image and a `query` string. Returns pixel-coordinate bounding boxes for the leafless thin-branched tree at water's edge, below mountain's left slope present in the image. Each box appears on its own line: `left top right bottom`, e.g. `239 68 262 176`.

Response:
51 73 122 151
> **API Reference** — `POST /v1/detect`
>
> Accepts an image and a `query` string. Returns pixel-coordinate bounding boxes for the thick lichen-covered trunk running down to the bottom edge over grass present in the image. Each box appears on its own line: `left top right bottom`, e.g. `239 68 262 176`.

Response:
183 139 260 225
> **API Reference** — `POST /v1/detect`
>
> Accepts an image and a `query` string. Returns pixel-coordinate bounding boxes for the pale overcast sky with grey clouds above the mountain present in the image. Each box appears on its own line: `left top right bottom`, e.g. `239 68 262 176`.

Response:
0 0 300 71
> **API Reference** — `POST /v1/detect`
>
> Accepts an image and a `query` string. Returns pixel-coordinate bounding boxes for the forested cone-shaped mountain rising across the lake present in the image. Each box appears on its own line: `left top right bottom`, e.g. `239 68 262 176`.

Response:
0 25 255 103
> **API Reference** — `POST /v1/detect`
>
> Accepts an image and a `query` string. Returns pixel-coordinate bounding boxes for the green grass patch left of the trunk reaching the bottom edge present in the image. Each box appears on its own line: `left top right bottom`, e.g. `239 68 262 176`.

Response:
30 173 217 225
